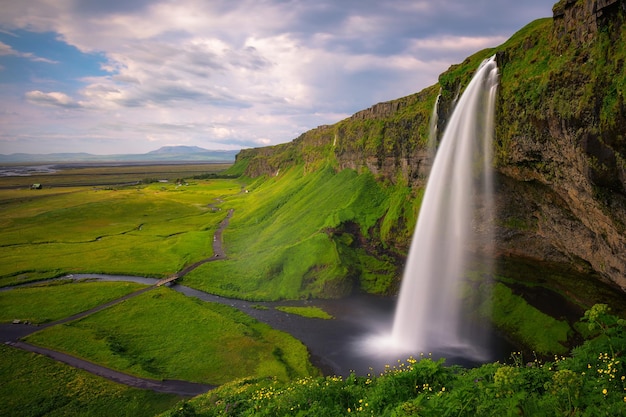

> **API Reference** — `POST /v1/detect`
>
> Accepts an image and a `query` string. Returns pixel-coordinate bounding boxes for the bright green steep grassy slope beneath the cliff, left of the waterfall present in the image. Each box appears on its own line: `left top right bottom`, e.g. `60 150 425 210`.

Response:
183 165 395 299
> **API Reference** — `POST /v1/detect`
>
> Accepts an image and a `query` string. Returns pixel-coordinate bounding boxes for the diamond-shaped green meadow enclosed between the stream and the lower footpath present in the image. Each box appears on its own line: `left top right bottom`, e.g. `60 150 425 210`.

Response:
26 287 317 384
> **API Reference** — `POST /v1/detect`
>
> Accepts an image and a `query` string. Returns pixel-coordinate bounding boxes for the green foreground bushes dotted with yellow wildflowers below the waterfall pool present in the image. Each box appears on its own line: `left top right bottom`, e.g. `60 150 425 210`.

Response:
164 304 626 417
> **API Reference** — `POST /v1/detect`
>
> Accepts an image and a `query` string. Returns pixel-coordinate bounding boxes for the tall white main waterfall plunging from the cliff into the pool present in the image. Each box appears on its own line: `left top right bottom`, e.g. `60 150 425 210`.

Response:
390 57 498 359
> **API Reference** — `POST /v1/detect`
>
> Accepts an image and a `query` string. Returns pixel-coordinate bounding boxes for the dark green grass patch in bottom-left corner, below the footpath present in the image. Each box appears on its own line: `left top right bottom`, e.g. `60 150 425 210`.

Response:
0 345 180 417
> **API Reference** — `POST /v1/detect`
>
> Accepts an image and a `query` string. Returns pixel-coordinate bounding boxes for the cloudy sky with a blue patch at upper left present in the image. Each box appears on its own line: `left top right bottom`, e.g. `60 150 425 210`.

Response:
0 0 556 154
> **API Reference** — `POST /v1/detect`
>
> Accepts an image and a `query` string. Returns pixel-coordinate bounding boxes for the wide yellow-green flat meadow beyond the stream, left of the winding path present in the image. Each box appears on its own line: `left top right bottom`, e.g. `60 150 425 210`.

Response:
0 176 241 286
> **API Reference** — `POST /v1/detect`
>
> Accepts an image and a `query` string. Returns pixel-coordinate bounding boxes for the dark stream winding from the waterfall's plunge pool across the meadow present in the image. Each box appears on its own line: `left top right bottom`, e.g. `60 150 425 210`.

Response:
67 274 512 376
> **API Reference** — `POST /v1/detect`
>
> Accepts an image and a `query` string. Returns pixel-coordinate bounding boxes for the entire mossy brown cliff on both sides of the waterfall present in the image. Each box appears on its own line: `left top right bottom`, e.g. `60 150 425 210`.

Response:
237 0 626 290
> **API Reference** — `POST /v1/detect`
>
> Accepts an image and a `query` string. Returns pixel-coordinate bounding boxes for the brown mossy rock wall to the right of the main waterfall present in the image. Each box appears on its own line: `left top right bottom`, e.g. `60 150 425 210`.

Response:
488 0 626 289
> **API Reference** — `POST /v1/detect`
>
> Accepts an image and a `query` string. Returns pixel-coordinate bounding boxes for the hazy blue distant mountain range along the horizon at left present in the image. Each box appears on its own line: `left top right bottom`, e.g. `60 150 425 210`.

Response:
0 146 239 164
